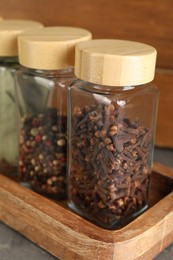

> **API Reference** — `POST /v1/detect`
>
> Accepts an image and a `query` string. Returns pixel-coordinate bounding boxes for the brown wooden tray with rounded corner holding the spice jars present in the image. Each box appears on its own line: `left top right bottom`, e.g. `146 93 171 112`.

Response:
0 164 173 260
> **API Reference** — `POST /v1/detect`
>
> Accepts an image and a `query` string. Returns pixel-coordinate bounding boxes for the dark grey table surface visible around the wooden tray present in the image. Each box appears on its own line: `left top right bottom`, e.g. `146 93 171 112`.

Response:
0 148 173 260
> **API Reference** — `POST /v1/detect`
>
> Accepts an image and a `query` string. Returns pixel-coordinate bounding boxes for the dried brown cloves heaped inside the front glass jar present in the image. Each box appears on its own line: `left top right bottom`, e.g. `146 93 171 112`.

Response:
69 102 152 228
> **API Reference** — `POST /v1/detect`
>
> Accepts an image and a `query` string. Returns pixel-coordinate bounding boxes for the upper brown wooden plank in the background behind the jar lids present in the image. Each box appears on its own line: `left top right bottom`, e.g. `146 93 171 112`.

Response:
0 0 173 68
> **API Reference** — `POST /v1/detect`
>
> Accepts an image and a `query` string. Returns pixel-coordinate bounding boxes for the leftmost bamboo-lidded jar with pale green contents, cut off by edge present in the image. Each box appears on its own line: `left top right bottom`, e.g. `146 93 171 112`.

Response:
0 20 42 176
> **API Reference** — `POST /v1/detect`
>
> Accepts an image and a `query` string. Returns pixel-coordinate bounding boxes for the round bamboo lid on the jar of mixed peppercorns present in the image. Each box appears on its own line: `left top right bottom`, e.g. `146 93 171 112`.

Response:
18 27 92 70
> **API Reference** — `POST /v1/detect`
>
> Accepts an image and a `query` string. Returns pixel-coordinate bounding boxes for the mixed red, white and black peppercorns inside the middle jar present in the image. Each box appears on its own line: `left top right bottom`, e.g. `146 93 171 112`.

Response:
19 108 67 197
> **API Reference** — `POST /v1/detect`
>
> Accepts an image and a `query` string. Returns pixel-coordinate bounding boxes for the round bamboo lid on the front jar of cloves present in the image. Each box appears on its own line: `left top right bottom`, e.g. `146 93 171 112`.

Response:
75 40 157 86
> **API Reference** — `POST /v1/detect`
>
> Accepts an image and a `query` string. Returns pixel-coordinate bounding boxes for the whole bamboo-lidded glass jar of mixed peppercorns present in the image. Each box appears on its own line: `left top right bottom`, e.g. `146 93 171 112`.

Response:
16 27 91 199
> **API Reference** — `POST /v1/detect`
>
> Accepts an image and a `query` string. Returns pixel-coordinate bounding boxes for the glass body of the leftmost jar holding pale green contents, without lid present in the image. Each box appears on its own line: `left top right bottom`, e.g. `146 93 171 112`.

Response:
0 57 21 176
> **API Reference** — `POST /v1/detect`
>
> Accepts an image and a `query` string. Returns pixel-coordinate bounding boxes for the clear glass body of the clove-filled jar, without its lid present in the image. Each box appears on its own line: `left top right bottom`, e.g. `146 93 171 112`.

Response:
68 80 159 229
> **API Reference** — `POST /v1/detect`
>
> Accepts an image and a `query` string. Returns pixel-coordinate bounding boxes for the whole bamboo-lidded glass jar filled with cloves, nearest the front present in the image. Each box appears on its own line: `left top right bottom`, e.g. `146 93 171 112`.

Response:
68 40 159 229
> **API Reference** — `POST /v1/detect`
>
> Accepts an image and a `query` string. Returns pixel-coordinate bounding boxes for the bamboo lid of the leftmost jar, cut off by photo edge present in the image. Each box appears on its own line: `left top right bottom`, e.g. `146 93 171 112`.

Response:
0 20 43 56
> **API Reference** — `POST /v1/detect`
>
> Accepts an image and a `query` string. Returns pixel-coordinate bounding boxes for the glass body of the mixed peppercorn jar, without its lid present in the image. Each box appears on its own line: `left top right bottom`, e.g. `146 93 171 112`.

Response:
16 69 74 199
